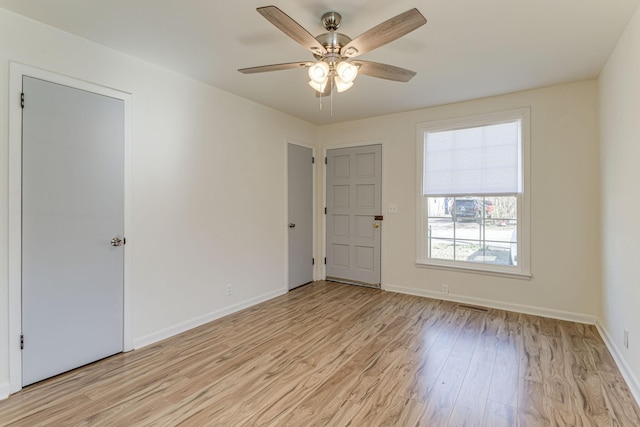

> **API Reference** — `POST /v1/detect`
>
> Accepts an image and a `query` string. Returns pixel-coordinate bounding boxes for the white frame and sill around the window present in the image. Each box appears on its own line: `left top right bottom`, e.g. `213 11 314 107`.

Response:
415 107 532 279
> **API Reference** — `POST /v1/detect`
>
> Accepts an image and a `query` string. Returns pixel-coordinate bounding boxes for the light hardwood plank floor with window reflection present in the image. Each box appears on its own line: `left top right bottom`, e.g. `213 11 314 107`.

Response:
0 282 640 427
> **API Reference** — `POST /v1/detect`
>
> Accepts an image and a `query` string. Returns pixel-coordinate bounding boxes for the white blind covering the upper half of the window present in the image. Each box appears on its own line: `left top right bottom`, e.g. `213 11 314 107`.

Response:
422 120 522 196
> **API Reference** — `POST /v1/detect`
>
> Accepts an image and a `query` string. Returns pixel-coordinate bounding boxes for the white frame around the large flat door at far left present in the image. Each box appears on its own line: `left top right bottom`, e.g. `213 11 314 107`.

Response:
8 62 133 393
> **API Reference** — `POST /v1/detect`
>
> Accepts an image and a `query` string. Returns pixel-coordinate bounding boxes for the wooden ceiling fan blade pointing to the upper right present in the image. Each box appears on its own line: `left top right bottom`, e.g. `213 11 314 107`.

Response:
340 8 427 58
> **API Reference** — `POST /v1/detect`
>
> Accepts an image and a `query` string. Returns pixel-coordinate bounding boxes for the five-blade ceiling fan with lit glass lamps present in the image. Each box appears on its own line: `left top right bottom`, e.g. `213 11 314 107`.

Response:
238 6 427 95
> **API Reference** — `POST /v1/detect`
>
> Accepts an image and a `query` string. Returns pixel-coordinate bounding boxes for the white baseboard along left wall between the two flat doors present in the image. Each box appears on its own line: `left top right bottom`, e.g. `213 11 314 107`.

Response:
133 288 288 349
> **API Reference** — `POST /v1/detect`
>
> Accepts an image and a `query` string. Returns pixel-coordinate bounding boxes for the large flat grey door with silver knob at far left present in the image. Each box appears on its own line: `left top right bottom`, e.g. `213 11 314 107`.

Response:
22 76 124 385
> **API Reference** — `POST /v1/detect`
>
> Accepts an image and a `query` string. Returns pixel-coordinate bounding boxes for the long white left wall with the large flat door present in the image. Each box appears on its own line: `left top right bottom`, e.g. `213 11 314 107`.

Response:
0 9 317 395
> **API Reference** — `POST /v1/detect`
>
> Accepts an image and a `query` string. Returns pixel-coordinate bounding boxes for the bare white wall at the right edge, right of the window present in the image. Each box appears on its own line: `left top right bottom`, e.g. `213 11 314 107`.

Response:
600 4 640 401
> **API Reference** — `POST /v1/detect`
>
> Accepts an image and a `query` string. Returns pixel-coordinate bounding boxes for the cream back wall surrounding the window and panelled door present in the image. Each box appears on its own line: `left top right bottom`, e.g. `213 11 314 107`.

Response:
318 81 600 322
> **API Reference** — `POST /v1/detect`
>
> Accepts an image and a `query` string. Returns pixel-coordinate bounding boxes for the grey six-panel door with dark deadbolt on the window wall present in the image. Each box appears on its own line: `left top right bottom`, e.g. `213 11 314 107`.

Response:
326 145 382 287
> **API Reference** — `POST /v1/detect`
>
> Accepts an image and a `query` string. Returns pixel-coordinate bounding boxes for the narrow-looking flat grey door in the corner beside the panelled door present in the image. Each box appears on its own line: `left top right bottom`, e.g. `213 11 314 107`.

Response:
287 144 313 289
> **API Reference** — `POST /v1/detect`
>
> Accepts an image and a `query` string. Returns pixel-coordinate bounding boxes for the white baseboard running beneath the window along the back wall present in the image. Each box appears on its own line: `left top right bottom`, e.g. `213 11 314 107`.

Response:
382 285 597 325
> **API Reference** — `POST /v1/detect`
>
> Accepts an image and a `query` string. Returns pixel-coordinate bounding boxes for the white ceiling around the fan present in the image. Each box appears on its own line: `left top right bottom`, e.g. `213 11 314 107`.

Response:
0 0 640 124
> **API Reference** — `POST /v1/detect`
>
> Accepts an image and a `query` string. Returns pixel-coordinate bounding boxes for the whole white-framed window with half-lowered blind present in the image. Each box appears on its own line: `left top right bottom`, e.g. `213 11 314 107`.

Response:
416 109 530 276
